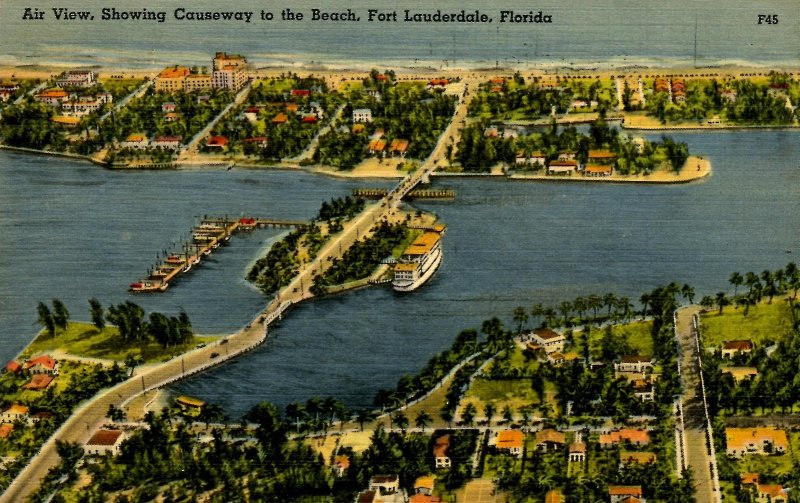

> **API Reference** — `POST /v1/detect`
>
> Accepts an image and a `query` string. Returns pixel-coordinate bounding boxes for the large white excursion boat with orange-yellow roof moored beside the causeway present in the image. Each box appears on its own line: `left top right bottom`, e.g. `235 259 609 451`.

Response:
392 228 444 292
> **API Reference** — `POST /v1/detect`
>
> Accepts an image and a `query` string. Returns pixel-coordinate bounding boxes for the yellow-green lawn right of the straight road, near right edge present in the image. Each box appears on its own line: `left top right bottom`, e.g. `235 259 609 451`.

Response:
701 297 792 348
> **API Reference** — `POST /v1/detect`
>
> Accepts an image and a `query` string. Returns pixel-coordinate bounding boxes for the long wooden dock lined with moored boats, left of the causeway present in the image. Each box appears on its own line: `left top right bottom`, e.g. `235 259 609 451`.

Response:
129 217 308 293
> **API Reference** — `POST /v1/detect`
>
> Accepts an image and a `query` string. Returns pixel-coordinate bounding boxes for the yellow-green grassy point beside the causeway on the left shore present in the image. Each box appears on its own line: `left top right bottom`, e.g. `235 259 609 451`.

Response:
22 322 217 363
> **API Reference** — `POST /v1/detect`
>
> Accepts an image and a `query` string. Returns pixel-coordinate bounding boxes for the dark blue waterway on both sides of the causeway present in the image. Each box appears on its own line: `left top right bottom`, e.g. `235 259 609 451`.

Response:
0 131 800 416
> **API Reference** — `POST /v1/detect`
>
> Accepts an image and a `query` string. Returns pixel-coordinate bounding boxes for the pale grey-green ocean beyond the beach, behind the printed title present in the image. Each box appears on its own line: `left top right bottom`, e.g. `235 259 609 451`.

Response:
0 0 800 68
